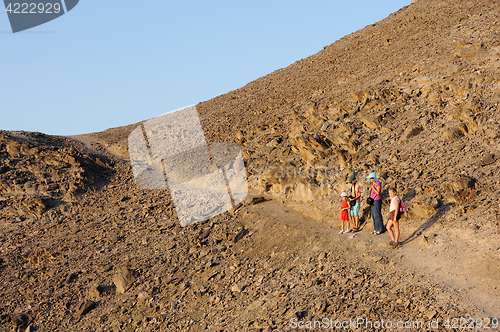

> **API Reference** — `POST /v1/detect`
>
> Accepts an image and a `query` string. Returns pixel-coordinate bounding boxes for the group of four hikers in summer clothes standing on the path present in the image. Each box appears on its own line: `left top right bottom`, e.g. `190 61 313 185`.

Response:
339 173 405 247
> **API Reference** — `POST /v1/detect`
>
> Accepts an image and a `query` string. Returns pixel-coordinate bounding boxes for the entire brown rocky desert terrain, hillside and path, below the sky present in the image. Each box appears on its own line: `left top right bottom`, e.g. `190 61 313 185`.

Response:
0 0 500 331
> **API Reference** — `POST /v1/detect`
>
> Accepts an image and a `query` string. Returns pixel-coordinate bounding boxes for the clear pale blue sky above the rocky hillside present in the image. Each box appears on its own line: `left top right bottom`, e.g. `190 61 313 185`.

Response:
0 0 410 135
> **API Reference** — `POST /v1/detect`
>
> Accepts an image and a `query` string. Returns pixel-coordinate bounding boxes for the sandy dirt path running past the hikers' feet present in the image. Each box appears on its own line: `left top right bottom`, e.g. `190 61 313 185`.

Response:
236 195 500 318
